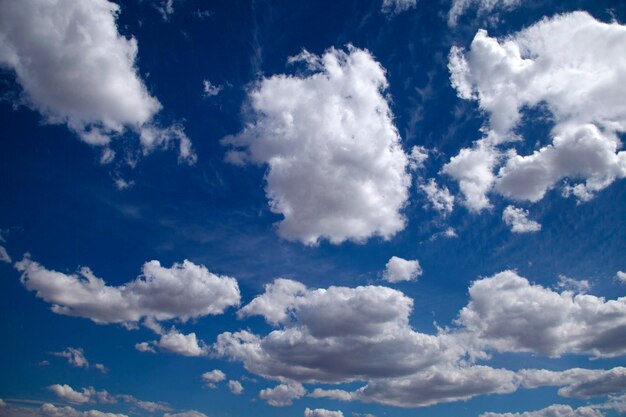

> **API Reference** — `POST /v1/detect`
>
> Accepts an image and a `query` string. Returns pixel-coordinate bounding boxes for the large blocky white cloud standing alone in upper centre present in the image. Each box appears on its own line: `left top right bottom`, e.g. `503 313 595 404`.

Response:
222 46 411 245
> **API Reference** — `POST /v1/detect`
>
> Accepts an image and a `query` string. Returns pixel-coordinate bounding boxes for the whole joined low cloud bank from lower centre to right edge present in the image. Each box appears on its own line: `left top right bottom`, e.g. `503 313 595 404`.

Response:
212 271 626 407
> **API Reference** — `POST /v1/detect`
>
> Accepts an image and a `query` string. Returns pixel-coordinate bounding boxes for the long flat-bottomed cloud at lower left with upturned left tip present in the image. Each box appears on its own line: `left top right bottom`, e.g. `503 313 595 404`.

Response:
15 256 240 323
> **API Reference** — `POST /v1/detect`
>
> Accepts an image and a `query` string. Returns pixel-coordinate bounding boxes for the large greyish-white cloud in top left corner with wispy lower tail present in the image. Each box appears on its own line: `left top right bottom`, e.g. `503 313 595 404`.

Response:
0 0 195 162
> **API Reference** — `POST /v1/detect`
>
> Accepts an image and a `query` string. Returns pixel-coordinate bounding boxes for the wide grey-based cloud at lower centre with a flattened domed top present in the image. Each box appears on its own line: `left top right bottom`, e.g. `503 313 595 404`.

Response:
213 280 461 383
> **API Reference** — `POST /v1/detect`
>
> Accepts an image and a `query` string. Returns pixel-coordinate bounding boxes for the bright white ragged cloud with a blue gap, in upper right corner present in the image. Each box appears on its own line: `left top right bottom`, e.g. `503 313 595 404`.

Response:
444 12 626 210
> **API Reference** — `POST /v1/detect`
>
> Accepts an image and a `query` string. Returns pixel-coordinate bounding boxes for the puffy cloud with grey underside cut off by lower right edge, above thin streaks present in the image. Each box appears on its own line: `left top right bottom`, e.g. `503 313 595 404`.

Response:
459 271 626 357
